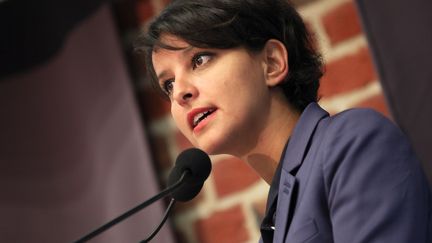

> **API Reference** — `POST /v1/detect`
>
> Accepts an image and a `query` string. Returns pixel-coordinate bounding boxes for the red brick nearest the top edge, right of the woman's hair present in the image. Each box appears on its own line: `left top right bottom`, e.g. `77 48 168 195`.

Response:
322 1 362 45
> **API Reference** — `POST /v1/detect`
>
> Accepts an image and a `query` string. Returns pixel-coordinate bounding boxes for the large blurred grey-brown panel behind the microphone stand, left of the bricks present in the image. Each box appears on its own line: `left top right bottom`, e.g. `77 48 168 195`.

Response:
0 0 174 243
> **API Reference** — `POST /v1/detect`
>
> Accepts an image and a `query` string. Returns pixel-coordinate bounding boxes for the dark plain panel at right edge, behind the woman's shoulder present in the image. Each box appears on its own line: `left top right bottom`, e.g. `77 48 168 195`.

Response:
356 0 432 184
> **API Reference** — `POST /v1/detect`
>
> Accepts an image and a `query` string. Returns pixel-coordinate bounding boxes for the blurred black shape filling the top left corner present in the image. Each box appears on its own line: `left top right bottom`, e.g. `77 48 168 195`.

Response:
0 0 106 78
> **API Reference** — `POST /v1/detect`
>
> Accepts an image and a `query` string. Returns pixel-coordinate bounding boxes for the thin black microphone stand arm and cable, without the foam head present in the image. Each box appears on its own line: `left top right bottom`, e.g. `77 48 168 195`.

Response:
74 170 190 243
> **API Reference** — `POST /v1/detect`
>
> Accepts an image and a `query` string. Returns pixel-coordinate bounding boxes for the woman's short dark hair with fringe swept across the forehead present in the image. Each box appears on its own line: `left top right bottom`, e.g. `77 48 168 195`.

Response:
136 0 323 111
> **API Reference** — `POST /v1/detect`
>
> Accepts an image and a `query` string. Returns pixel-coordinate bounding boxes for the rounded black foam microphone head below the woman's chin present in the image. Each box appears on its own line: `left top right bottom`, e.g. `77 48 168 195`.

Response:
168 148 211 202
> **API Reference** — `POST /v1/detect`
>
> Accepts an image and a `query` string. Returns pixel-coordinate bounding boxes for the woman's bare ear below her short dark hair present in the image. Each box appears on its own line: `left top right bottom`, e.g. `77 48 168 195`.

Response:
263 39 289 87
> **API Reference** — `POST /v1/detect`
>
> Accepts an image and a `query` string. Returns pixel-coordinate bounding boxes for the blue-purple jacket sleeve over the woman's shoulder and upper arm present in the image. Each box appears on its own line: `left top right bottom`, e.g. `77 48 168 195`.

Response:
314 109 431 242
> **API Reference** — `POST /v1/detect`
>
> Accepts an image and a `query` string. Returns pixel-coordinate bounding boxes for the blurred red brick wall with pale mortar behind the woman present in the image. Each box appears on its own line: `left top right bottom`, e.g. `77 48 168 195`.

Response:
132 0 389 243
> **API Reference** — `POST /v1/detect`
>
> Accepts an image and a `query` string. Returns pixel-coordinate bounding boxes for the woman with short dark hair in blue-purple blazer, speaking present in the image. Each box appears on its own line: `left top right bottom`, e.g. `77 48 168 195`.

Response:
138 0 432 243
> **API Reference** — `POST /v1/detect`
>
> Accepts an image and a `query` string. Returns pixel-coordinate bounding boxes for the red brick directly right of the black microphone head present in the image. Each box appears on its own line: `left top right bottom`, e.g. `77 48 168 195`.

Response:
212 157 260 197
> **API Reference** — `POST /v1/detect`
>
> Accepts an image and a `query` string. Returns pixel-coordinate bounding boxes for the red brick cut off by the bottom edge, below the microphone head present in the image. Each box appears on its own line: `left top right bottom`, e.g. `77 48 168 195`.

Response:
195 206 249 243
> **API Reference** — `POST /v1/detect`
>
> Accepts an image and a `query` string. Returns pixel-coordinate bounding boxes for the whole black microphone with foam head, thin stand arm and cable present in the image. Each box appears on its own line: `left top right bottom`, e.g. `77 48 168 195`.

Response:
74 148 211 243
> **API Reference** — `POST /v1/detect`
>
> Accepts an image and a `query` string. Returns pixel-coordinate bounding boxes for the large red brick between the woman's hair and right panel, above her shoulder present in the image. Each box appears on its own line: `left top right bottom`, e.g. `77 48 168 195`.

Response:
319 48 377 97
